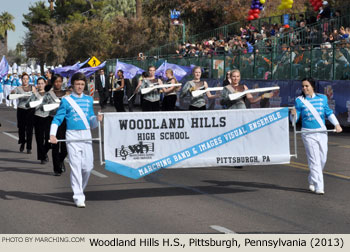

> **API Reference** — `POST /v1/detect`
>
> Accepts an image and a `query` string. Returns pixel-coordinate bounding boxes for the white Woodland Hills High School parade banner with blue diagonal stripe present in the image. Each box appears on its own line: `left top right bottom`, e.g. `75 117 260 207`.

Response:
104 108 290 179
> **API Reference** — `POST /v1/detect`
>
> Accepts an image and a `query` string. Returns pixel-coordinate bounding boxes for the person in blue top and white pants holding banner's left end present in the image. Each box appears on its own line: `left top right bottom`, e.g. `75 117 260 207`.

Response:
50 73 102 208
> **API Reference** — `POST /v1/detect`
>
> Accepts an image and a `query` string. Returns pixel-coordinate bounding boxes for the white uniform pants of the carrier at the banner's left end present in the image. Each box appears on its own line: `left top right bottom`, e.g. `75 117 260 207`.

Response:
66 130 94 203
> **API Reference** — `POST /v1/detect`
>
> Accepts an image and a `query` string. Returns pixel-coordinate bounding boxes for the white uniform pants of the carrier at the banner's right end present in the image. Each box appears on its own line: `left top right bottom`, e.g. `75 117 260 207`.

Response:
302 133 328 191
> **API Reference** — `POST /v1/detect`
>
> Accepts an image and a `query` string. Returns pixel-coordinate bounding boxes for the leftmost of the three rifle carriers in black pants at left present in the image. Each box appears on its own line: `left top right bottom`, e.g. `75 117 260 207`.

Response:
11 73 36 154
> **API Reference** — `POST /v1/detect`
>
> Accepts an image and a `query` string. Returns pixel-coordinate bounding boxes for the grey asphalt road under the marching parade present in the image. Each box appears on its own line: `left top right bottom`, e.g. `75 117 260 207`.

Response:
0 105 350 234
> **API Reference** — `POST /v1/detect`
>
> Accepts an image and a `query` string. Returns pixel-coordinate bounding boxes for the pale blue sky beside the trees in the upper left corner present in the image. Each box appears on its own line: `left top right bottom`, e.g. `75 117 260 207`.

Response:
0 0 48 49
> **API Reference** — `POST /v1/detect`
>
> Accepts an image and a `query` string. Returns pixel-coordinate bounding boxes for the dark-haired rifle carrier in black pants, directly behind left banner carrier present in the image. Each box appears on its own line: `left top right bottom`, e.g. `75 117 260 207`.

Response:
43 74 68 176
